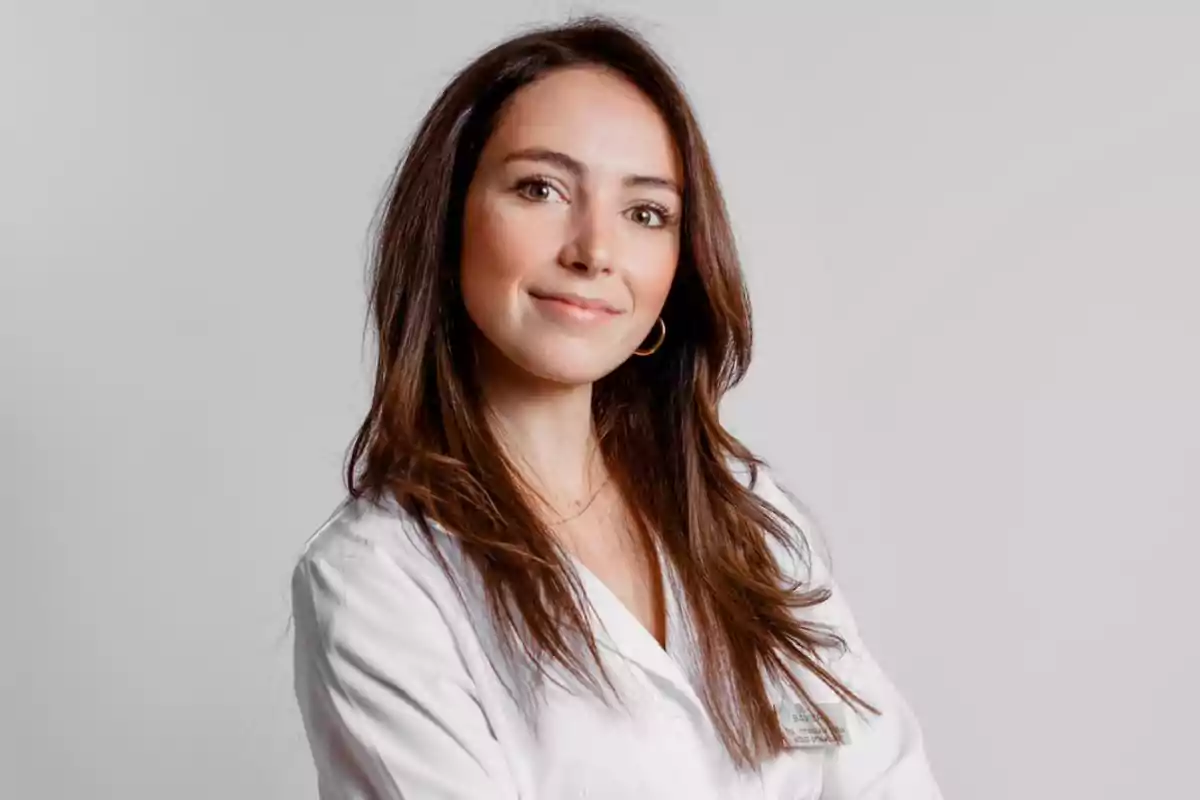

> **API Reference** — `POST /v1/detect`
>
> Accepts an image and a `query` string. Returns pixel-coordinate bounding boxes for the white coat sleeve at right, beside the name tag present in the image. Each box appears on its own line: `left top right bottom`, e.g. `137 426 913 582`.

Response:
766 477 942 800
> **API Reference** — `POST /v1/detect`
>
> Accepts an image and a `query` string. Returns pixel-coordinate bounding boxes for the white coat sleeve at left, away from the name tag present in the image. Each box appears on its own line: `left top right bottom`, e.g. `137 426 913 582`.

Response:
292 540 517 800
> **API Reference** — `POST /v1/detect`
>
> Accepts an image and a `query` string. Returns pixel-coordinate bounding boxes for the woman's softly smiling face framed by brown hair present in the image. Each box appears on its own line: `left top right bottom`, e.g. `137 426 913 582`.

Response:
461 67 683 384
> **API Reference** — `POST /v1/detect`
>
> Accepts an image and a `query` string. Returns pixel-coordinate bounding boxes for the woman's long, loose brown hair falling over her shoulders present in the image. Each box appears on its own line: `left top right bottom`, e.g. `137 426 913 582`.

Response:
346 17 877 765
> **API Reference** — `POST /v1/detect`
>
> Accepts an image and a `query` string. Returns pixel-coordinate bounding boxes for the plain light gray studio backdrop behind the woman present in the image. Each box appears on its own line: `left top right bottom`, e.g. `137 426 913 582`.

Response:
0 0 1200 800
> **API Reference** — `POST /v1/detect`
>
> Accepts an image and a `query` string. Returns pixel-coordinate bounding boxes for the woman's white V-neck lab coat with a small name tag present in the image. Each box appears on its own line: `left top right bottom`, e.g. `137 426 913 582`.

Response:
293 471 941 800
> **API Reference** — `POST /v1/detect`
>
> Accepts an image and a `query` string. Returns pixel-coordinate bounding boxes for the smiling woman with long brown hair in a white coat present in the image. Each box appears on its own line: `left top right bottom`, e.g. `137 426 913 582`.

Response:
293 14 940 800
